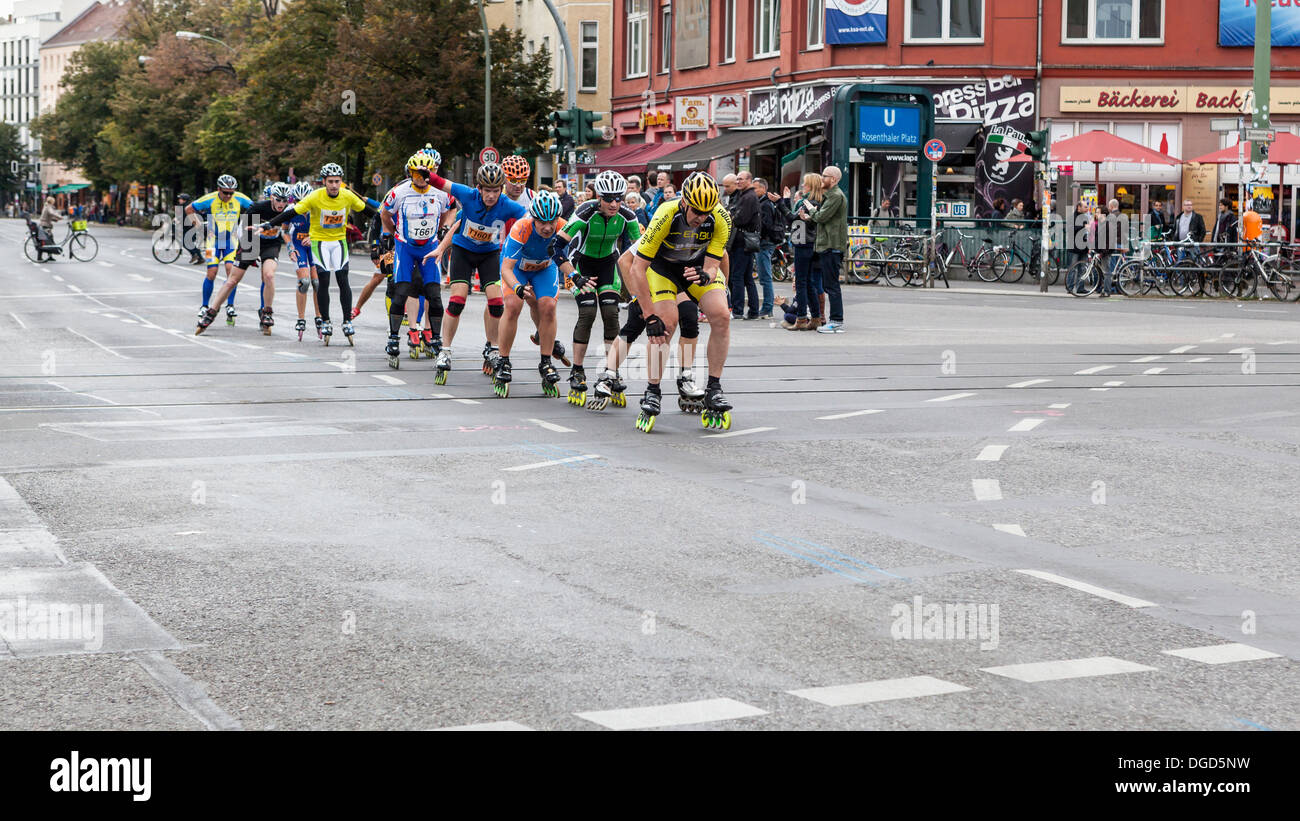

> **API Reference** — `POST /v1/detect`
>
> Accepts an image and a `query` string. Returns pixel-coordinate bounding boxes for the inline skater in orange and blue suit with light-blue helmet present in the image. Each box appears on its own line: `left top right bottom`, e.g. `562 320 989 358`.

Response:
493 191 564 398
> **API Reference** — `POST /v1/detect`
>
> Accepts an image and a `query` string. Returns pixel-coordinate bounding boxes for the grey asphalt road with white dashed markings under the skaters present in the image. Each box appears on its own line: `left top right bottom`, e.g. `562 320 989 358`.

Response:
0 221 1300 731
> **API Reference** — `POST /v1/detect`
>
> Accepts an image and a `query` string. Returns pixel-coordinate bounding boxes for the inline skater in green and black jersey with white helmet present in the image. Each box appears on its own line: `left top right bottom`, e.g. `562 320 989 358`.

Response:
551 171 641 405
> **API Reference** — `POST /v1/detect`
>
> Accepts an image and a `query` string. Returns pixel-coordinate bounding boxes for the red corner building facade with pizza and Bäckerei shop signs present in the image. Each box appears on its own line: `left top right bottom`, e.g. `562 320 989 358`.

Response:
611 0 1300 216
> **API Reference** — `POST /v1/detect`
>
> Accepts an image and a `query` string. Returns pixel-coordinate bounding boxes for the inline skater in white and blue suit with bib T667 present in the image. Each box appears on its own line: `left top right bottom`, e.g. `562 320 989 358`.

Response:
380 152 451 368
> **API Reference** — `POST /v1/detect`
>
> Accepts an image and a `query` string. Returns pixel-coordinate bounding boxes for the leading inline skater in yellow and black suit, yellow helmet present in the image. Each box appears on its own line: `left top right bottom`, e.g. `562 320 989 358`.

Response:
627 171 732 433
